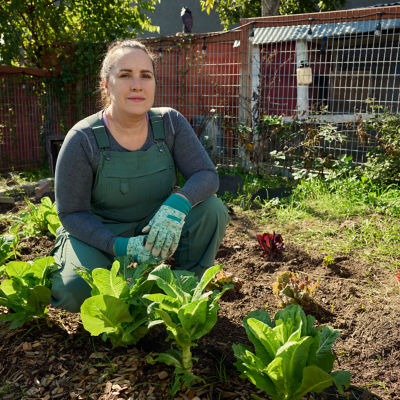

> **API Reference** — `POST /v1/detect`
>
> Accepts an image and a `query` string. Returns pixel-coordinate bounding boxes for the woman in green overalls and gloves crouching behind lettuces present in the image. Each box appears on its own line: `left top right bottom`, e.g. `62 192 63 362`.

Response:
52 40 229 312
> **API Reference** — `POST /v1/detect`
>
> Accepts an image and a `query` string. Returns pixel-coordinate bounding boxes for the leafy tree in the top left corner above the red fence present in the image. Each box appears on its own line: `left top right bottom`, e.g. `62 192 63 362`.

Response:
0 0 160 68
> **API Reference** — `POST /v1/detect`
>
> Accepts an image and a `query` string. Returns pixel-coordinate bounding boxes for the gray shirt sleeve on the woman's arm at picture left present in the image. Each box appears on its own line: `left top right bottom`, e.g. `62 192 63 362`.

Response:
55 124 116 254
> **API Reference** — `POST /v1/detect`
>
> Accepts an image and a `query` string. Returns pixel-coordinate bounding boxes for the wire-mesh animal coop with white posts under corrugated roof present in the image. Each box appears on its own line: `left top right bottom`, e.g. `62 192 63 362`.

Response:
241 6 400 170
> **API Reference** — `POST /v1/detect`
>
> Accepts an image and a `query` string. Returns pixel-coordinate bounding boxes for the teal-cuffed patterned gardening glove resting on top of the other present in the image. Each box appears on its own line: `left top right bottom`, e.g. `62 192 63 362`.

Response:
142 193 192 259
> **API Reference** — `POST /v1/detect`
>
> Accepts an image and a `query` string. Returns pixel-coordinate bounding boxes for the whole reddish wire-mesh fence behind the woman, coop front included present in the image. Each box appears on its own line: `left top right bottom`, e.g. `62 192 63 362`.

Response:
0 6 400 171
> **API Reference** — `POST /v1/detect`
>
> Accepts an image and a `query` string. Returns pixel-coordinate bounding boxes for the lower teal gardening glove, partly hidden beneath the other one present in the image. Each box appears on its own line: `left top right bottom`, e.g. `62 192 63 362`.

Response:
114 236 163 265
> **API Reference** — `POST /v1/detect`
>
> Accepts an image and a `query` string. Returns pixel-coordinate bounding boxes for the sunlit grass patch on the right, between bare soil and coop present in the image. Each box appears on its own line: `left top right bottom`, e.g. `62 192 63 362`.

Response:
223 170 400 271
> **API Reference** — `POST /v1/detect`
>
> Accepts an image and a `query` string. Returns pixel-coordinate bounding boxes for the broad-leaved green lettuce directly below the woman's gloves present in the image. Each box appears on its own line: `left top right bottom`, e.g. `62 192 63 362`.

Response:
76 261 159 347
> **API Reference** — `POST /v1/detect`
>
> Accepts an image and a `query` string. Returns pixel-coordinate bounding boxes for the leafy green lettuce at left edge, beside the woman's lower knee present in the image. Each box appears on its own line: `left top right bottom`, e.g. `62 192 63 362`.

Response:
0 257 57 329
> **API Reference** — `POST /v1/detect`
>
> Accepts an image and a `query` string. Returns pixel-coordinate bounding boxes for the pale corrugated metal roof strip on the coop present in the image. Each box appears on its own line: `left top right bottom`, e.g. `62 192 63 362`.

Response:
253 19 400 44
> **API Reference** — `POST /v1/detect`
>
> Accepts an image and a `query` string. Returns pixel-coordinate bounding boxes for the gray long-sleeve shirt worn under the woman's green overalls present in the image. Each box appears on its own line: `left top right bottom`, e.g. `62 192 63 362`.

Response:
55 108 219 254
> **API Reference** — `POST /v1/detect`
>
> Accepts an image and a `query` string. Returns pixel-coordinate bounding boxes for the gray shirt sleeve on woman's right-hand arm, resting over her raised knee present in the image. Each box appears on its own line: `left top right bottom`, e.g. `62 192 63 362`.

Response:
164 109 219 206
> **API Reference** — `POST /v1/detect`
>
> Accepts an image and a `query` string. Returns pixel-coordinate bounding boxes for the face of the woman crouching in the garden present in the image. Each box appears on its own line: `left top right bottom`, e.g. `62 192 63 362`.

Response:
105 48 156 115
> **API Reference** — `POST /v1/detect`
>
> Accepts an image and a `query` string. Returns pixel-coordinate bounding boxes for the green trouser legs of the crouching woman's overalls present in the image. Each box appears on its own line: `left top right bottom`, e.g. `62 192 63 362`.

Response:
51 196 229 312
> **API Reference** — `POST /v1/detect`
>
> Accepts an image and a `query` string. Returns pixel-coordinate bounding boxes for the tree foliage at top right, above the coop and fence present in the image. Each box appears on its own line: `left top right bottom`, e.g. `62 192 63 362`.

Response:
200 0 346 29
